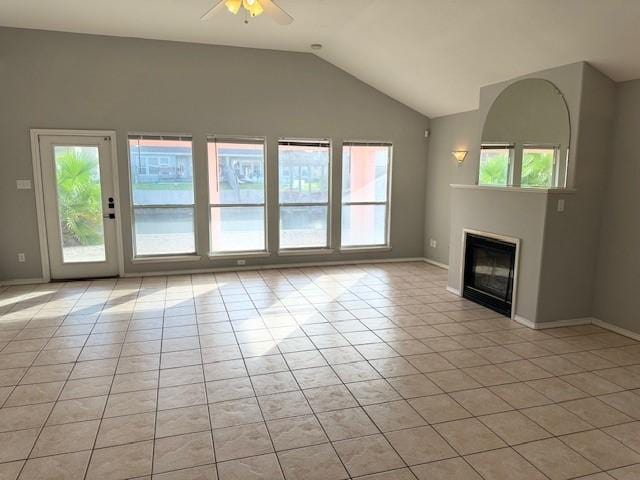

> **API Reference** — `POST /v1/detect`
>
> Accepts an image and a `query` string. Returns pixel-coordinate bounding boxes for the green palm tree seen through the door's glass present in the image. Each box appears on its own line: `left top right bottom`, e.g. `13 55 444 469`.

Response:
56 148 103 245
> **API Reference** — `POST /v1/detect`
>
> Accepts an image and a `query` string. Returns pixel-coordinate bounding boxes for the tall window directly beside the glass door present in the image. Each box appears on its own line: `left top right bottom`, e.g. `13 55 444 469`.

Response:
129 135 196 257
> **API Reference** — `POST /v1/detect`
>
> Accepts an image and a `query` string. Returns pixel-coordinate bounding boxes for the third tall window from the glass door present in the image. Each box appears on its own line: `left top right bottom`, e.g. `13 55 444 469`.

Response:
278 140 331 250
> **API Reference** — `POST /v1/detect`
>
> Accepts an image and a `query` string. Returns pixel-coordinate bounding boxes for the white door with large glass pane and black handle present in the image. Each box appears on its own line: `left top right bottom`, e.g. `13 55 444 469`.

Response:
38 134 118 279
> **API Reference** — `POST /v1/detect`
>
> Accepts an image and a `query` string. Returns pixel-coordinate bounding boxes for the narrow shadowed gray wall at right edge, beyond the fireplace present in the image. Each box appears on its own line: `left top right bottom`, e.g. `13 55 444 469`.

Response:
594 80 640 333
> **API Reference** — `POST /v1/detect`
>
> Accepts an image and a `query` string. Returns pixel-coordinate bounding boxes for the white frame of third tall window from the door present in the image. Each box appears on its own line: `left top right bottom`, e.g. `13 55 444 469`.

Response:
277 137 333 255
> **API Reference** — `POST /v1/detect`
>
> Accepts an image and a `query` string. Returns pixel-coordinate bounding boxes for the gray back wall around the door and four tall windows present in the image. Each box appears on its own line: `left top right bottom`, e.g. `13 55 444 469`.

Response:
0 28 429 280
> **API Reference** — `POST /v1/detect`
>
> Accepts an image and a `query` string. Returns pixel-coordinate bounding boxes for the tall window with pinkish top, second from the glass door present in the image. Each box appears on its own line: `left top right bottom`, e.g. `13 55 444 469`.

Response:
207 137 266 254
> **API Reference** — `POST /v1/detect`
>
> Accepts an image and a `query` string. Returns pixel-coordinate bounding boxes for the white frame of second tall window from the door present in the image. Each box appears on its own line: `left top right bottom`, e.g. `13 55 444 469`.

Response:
206 134 270 258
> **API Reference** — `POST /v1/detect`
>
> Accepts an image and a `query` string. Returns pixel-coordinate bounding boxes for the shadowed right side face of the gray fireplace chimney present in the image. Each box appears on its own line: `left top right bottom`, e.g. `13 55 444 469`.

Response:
538 64 616 322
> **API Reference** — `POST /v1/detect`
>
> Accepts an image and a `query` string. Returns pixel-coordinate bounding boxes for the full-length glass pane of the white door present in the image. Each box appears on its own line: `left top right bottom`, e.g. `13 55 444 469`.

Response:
53 145 106 263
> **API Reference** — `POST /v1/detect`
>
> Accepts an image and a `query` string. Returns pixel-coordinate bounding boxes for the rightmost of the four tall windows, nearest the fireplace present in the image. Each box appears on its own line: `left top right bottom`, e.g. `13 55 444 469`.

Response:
341 142 391 248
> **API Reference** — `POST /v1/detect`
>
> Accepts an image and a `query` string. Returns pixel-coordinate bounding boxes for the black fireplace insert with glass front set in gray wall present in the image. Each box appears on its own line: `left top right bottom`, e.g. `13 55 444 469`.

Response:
462 233 516 317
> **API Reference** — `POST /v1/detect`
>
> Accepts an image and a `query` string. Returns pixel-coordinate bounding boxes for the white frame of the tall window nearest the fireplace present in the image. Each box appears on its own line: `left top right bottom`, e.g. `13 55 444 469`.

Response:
340 140 393 251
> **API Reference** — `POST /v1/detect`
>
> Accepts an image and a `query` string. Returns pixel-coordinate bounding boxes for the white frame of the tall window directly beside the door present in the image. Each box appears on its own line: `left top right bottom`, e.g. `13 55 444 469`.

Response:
127 132 200 263
